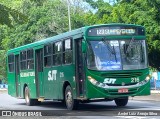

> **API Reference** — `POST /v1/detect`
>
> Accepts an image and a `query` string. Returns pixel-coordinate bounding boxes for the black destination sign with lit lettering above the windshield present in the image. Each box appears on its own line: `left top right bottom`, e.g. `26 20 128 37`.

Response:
88 27 144 36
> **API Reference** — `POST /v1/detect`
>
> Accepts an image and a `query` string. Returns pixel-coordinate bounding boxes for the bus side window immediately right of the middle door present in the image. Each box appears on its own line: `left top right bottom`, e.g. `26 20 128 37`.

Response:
44 44 52 67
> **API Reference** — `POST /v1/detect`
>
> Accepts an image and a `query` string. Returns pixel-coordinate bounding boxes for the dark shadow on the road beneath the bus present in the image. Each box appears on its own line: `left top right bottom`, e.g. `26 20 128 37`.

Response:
17 101 146 112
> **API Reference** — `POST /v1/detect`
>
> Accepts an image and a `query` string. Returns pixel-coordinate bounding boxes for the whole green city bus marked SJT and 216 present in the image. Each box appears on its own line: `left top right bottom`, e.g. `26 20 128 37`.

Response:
7 24 150 110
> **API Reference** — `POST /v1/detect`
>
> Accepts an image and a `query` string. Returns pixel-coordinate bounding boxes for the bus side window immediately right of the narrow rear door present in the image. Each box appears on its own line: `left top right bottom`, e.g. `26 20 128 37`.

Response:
20 51 27 70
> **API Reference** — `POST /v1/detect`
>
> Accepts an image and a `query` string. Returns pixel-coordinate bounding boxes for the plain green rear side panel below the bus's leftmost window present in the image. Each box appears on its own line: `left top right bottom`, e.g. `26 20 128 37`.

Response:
8 73 16 97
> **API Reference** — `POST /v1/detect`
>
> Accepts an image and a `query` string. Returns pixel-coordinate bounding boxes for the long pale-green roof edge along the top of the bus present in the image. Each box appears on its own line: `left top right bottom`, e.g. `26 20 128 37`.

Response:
7 23 143 54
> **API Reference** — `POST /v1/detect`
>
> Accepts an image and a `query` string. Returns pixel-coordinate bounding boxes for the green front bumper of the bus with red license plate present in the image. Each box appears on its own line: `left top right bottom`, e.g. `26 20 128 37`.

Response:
87 80 150 99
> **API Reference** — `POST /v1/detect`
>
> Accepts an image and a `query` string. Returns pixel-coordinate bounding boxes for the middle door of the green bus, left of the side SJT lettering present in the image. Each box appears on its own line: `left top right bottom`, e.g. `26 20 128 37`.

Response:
35 49 44 97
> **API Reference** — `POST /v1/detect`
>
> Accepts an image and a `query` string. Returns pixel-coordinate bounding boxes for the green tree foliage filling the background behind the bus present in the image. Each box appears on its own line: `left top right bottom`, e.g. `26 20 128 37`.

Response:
0 0 160 81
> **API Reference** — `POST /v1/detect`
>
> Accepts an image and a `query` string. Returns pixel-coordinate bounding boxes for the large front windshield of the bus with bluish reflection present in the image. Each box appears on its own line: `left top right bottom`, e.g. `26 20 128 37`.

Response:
87 38 147 71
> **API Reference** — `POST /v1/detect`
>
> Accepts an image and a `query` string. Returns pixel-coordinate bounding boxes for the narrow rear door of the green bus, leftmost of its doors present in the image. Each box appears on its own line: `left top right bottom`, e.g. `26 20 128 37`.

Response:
15 54 21 97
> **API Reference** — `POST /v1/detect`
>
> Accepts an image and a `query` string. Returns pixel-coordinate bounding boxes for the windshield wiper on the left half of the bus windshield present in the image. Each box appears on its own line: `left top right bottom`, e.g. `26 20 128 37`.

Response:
102 38 117 62
